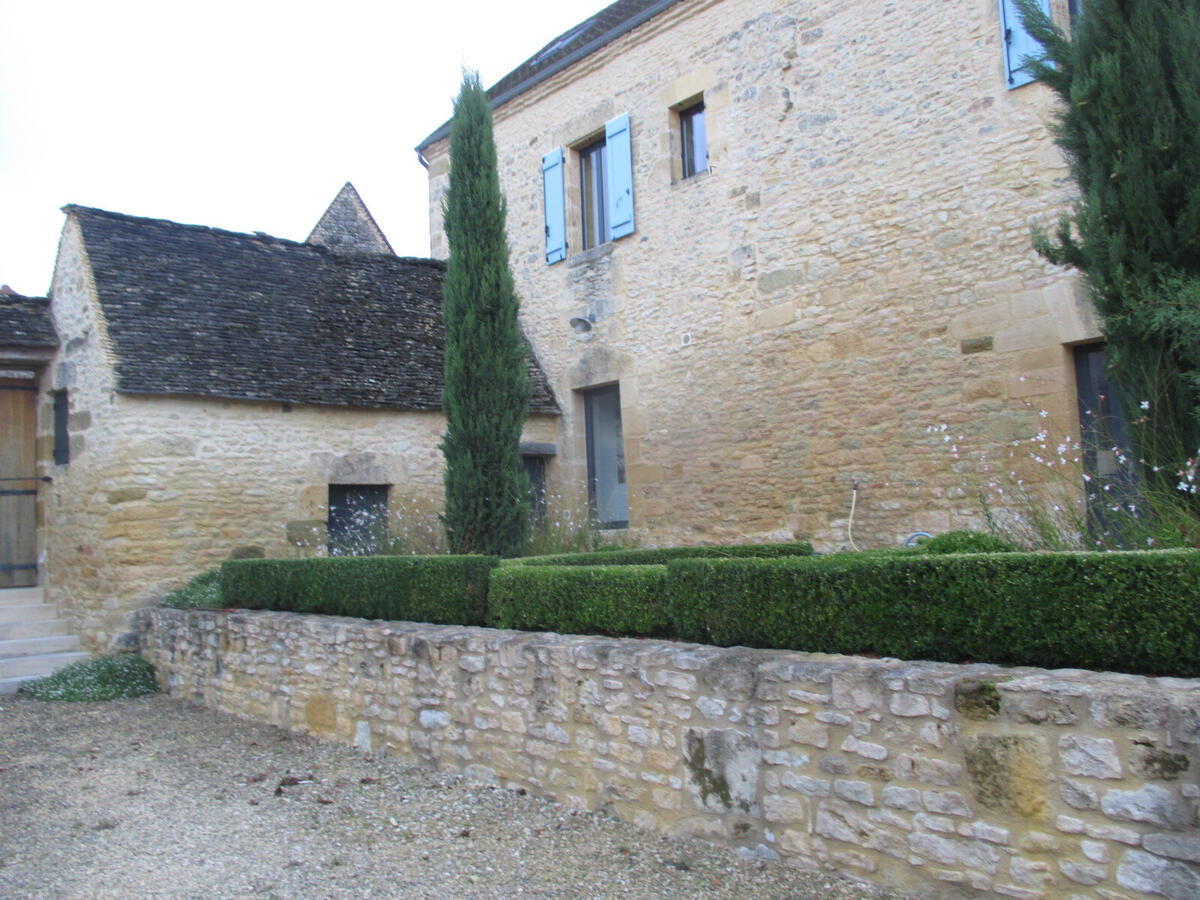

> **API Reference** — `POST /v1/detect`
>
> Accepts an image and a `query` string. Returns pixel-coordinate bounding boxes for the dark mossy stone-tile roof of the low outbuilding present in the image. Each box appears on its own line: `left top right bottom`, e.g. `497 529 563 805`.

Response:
65 206 559 413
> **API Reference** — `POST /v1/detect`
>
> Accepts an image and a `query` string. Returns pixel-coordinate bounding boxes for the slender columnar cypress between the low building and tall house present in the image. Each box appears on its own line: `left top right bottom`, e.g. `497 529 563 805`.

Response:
442 72 530 556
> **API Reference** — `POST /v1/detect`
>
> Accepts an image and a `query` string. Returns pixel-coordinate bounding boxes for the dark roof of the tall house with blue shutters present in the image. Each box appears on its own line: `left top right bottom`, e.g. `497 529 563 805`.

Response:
416 0 679 152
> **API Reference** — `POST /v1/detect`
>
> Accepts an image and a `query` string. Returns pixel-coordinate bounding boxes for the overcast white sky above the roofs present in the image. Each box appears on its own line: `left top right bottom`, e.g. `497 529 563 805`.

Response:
0 0 607 295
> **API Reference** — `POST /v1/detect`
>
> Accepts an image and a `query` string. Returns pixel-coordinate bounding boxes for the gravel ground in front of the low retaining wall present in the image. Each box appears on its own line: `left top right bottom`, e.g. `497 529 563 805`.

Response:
0 695 916 900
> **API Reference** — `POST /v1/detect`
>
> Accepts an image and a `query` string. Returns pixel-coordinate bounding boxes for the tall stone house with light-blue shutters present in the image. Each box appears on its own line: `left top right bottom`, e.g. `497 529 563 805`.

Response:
418 0 1104 548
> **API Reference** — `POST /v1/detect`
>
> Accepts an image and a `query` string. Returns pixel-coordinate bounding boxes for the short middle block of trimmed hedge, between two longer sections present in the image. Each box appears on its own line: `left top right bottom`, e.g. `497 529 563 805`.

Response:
487 565 667 636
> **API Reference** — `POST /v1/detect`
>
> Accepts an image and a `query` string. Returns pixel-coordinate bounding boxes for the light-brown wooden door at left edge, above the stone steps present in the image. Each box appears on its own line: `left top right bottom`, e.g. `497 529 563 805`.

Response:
0 374 37 588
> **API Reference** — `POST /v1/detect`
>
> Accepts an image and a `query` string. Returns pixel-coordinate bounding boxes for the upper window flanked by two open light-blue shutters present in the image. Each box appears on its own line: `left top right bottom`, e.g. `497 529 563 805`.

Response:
541 113 634 265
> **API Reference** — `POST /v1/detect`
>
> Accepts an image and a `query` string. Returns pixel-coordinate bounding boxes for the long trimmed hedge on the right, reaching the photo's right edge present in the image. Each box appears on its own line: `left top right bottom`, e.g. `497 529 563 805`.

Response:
668 551 1200 677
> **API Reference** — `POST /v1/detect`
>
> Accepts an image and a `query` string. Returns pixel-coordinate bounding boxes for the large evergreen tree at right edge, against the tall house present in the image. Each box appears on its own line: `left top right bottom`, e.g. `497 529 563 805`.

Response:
1018 0 1200 487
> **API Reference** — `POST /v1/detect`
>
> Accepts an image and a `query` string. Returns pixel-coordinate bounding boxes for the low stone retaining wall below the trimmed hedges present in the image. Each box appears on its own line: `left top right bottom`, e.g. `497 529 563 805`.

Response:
139 608 1200 900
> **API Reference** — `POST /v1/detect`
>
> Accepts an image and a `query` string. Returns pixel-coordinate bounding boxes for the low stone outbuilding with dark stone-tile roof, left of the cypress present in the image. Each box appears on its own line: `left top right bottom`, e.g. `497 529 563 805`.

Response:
0 185 558 648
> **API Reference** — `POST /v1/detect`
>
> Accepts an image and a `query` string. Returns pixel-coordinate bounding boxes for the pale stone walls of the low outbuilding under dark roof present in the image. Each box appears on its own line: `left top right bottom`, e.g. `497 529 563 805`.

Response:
37 217 556 649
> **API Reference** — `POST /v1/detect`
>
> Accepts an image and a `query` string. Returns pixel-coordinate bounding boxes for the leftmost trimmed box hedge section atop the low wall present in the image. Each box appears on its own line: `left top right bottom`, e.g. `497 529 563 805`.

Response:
221 556 499 625
